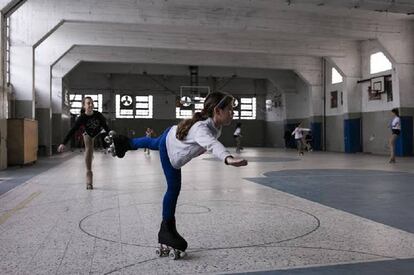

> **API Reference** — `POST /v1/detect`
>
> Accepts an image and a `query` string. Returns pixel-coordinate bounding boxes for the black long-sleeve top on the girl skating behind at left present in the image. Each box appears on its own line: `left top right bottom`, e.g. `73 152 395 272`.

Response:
62 111 110 144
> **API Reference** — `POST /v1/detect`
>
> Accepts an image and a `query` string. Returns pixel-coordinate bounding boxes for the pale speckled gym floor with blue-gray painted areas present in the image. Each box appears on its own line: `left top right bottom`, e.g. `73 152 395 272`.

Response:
0 148 414 274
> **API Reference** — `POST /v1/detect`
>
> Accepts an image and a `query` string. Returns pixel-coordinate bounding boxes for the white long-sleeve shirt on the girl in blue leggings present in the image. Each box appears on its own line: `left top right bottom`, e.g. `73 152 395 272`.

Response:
166 118 231 169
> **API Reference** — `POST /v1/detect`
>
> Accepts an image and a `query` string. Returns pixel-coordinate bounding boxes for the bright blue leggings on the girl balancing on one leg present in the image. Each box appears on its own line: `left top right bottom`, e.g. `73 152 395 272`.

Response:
130 128 181 220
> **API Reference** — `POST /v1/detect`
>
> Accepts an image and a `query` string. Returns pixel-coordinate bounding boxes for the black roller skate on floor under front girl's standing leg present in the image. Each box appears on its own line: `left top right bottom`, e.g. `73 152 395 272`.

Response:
155 219 188 260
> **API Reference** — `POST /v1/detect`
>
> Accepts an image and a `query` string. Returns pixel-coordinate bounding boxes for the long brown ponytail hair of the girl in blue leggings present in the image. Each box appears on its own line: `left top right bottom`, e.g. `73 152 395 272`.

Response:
176 92 234 140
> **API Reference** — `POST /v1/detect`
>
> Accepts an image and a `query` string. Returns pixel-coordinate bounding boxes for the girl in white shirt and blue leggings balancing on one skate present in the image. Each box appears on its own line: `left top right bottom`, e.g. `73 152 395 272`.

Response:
108 92 247 256
